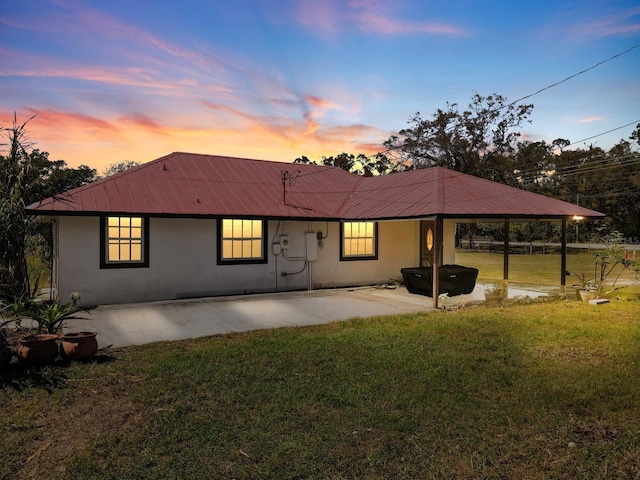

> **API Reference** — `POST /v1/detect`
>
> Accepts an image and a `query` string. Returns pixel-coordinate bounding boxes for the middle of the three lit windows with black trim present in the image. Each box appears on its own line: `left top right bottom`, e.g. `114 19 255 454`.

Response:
218 218 267 264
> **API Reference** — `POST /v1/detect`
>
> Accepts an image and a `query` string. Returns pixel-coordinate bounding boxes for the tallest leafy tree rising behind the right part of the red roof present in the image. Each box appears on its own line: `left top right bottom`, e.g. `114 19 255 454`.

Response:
384 93 533 184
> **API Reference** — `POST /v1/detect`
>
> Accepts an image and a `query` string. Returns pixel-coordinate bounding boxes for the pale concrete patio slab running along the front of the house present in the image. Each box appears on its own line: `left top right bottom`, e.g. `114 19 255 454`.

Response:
64 285 548 348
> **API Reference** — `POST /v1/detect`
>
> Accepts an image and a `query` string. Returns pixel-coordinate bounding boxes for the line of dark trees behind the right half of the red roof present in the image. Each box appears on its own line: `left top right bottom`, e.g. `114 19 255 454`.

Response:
294 93 640 241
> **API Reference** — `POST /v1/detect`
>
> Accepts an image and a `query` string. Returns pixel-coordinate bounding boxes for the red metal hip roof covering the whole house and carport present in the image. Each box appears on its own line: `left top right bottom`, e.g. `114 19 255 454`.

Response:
27 153 604 220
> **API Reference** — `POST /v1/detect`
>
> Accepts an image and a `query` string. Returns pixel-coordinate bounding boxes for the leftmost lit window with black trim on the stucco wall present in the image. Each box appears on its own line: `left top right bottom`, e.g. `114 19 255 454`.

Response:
100 216 149 268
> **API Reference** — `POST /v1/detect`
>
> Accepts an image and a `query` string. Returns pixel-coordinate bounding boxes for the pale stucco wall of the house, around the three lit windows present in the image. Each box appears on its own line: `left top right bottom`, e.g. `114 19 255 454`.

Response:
56 217 419 304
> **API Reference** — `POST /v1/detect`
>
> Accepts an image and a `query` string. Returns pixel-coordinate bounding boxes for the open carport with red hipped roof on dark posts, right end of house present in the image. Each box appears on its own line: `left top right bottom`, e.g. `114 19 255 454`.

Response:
344 167 605 308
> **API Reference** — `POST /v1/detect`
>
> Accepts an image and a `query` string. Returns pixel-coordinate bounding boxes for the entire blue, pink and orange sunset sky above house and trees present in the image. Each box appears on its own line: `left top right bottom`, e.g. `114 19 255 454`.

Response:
0 0 640 173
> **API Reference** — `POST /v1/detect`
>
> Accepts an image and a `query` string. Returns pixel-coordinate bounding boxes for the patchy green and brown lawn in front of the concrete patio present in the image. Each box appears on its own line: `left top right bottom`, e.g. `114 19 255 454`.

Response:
0 300 640 479
